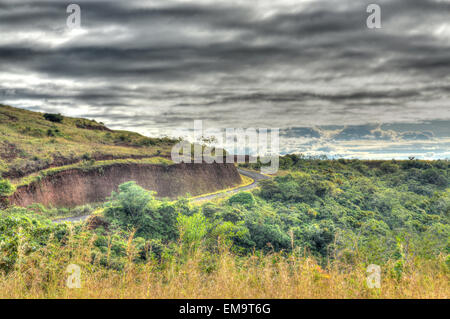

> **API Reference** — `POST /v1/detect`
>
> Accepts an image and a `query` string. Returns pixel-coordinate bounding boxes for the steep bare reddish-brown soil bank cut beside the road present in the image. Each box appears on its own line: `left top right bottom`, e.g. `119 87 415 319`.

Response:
9 163 241 207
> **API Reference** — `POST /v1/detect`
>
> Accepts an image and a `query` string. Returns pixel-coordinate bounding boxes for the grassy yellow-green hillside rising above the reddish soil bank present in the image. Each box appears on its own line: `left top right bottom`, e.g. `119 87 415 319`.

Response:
0 104 174 179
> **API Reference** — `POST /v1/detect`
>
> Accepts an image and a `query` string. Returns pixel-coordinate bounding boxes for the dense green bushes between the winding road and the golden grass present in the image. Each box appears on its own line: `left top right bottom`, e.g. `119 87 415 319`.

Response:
0 155 450 272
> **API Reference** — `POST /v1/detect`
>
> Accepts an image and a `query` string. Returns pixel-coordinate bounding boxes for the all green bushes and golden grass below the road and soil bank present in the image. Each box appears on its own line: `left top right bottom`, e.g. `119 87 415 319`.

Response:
0 159 450 299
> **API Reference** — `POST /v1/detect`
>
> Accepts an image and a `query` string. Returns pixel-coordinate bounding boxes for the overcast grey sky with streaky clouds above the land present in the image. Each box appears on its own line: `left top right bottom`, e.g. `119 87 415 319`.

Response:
0 0 450 158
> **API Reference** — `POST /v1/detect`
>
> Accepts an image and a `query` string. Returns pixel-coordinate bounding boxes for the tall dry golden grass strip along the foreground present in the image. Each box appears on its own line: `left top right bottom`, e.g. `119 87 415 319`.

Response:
0 228 450 298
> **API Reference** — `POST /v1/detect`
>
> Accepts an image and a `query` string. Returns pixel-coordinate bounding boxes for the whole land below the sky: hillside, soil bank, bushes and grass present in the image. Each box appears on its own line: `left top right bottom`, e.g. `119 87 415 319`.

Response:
0 106 450 298
